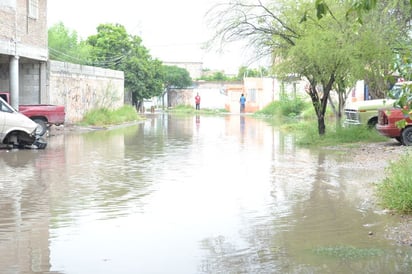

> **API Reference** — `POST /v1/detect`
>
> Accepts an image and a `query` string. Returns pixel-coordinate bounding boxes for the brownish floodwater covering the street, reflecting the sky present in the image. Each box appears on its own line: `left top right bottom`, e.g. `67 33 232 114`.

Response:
0 115 412 274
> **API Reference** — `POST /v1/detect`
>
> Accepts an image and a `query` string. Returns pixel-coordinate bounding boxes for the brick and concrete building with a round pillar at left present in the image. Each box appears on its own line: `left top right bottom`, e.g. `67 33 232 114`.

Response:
0 0 49 108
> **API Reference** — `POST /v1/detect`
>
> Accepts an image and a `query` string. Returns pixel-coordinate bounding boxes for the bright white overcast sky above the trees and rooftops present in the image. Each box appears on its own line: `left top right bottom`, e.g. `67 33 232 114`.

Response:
48 0 264 73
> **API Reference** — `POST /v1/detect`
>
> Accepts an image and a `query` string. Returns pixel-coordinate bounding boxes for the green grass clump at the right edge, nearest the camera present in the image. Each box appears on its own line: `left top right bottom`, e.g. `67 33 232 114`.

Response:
377 153 412 214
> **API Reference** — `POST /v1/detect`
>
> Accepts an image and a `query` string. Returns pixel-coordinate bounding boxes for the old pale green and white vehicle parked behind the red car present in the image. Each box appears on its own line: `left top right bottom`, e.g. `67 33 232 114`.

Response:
344 81 412 127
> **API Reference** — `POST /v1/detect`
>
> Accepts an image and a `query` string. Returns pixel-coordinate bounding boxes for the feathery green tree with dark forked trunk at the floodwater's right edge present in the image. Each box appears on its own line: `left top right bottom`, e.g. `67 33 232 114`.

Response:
212 0 408 135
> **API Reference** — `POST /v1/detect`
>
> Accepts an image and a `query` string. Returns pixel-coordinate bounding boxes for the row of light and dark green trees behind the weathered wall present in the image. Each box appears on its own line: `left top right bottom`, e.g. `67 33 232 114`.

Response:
49 23 192 109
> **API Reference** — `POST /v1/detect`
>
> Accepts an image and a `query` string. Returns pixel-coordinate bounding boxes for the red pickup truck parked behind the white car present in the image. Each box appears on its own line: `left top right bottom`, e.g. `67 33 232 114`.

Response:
0 92 66 136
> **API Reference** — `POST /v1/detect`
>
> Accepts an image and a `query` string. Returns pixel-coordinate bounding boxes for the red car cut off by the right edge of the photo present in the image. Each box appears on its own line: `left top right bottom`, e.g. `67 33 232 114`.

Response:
376 108 412 146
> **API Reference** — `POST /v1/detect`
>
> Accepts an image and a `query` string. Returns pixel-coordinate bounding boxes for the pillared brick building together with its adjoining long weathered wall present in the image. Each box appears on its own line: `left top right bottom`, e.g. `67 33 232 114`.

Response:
0 0 124 124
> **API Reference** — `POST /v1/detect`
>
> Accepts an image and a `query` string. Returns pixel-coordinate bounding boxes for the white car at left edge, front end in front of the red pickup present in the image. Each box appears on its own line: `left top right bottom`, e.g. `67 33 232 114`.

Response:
0 98 47 149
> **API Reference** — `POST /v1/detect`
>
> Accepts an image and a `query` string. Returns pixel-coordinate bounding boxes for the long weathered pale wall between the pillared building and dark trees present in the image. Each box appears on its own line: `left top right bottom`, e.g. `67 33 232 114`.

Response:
48 61 124 124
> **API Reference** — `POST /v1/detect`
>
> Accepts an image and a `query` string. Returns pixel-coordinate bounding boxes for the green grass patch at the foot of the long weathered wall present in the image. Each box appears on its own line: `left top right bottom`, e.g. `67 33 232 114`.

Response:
79 105 142 126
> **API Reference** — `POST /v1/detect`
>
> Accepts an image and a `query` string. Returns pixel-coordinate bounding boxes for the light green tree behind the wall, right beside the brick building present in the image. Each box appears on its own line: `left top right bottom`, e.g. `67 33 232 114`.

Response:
48 22 90 65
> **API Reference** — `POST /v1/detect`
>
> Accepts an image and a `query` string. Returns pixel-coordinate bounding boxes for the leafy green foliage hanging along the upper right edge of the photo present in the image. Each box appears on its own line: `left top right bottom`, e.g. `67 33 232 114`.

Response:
315 0 412 128
